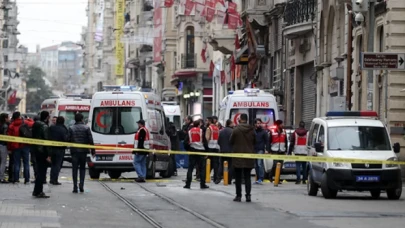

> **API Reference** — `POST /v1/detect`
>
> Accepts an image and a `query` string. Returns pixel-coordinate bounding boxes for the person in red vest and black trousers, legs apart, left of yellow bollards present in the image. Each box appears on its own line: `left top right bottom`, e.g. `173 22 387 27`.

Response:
184 120 209 189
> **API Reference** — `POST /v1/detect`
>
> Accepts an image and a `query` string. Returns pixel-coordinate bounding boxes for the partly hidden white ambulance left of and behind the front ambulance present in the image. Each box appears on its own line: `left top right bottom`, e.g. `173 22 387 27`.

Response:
41 95 91 162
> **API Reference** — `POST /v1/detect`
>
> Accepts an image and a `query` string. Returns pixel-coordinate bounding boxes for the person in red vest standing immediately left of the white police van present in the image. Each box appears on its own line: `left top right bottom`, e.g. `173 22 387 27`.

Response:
288 121 308 184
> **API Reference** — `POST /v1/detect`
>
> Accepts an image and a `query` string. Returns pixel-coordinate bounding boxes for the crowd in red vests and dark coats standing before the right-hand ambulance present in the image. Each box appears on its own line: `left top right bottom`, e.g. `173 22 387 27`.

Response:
178 114 307 202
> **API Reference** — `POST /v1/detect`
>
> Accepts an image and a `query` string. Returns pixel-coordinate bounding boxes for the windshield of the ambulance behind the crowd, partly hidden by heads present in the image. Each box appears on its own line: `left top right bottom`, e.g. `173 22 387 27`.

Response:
230 108 276 128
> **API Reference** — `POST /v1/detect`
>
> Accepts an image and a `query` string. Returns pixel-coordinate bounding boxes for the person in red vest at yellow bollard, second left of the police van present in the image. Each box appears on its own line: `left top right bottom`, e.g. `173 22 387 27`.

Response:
269 120 288 182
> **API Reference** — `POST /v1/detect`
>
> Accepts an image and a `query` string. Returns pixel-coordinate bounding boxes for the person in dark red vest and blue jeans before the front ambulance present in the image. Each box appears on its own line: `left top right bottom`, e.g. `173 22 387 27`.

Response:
134 120 149 182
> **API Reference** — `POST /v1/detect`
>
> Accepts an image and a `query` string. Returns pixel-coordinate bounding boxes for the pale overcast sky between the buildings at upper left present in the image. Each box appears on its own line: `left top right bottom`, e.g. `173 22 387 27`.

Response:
14 0 88 52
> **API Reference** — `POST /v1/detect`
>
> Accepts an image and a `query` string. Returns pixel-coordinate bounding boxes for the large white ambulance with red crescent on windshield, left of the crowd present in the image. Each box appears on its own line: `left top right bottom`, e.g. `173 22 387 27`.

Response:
88 86 174 179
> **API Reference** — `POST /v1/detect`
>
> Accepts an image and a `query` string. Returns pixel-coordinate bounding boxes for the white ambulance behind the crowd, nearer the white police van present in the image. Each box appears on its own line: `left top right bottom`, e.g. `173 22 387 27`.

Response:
218 88 279 126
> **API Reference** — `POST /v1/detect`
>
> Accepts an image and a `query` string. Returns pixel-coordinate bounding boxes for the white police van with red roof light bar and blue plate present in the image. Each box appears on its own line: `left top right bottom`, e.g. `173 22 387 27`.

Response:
307 111 402 199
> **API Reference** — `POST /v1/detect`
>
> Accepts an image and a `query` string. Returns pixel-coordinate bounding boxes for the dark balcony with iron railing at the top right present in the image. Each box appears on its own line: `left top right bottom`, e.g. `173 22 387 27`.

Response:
284 0 317 39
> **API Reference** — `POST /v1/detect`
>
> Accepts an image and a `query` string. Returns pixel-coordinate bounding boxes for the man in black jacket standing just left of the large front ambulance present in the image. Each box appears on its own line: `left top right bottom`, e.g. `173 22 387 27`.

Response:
68 113 95 193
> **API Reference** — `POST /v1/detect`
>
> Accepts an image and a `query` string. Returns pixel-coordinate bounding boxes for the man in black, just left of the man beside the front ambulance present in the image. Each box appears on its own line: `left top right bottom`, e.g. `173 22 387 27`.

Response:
49 116 68 185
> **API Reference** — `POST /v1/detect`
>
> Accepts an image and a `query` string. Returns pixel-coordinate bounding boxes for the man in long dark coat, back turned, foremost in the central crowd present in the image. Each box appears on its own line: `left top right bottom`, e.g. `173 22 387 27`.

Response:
230 114 256 202
